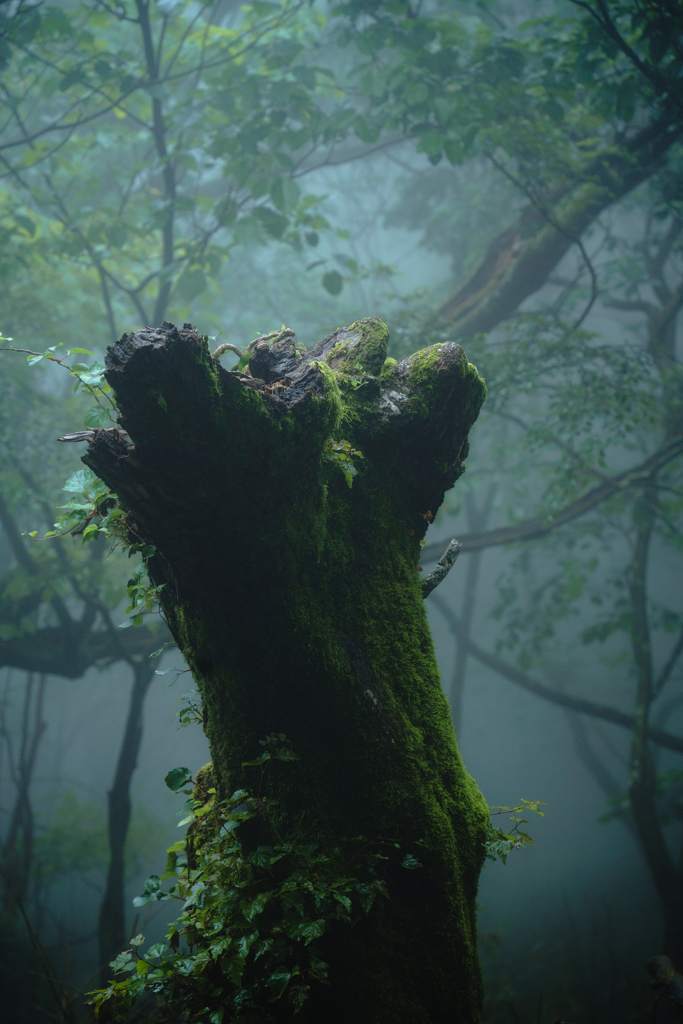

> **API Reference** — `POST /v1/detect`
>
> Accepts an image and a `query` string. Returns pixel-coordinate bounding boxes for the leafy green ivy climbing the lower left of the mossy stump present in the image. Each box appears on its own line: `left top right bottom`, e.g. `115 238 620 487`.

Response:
91 733 405 1024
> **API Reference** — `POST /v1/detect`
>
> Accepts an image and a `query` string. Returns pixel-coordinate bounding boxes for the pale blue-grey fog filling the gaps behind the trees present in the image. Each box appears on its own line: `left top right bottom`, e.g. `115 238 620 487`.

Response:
0 3 683 1024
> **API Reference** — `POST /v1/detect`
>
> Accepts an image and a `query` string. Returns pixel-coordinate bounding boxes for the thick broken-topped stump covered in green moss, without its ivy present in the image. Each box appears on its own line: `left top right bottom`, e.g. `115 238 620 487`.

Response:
84 318 487 1024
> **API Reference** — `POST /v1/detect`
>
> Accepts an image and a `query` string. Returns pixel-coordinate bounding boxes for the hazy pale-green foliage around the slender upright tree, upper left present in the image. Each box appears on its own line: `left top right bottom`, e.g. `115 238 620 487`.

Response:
0 0 362 330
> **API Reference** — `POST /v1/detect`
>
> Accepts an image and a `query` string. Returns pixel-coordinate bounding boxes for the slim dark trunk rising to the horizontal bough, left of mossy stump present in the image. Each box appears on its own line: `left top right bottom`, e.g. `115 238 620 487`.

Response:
97 657 154 985
